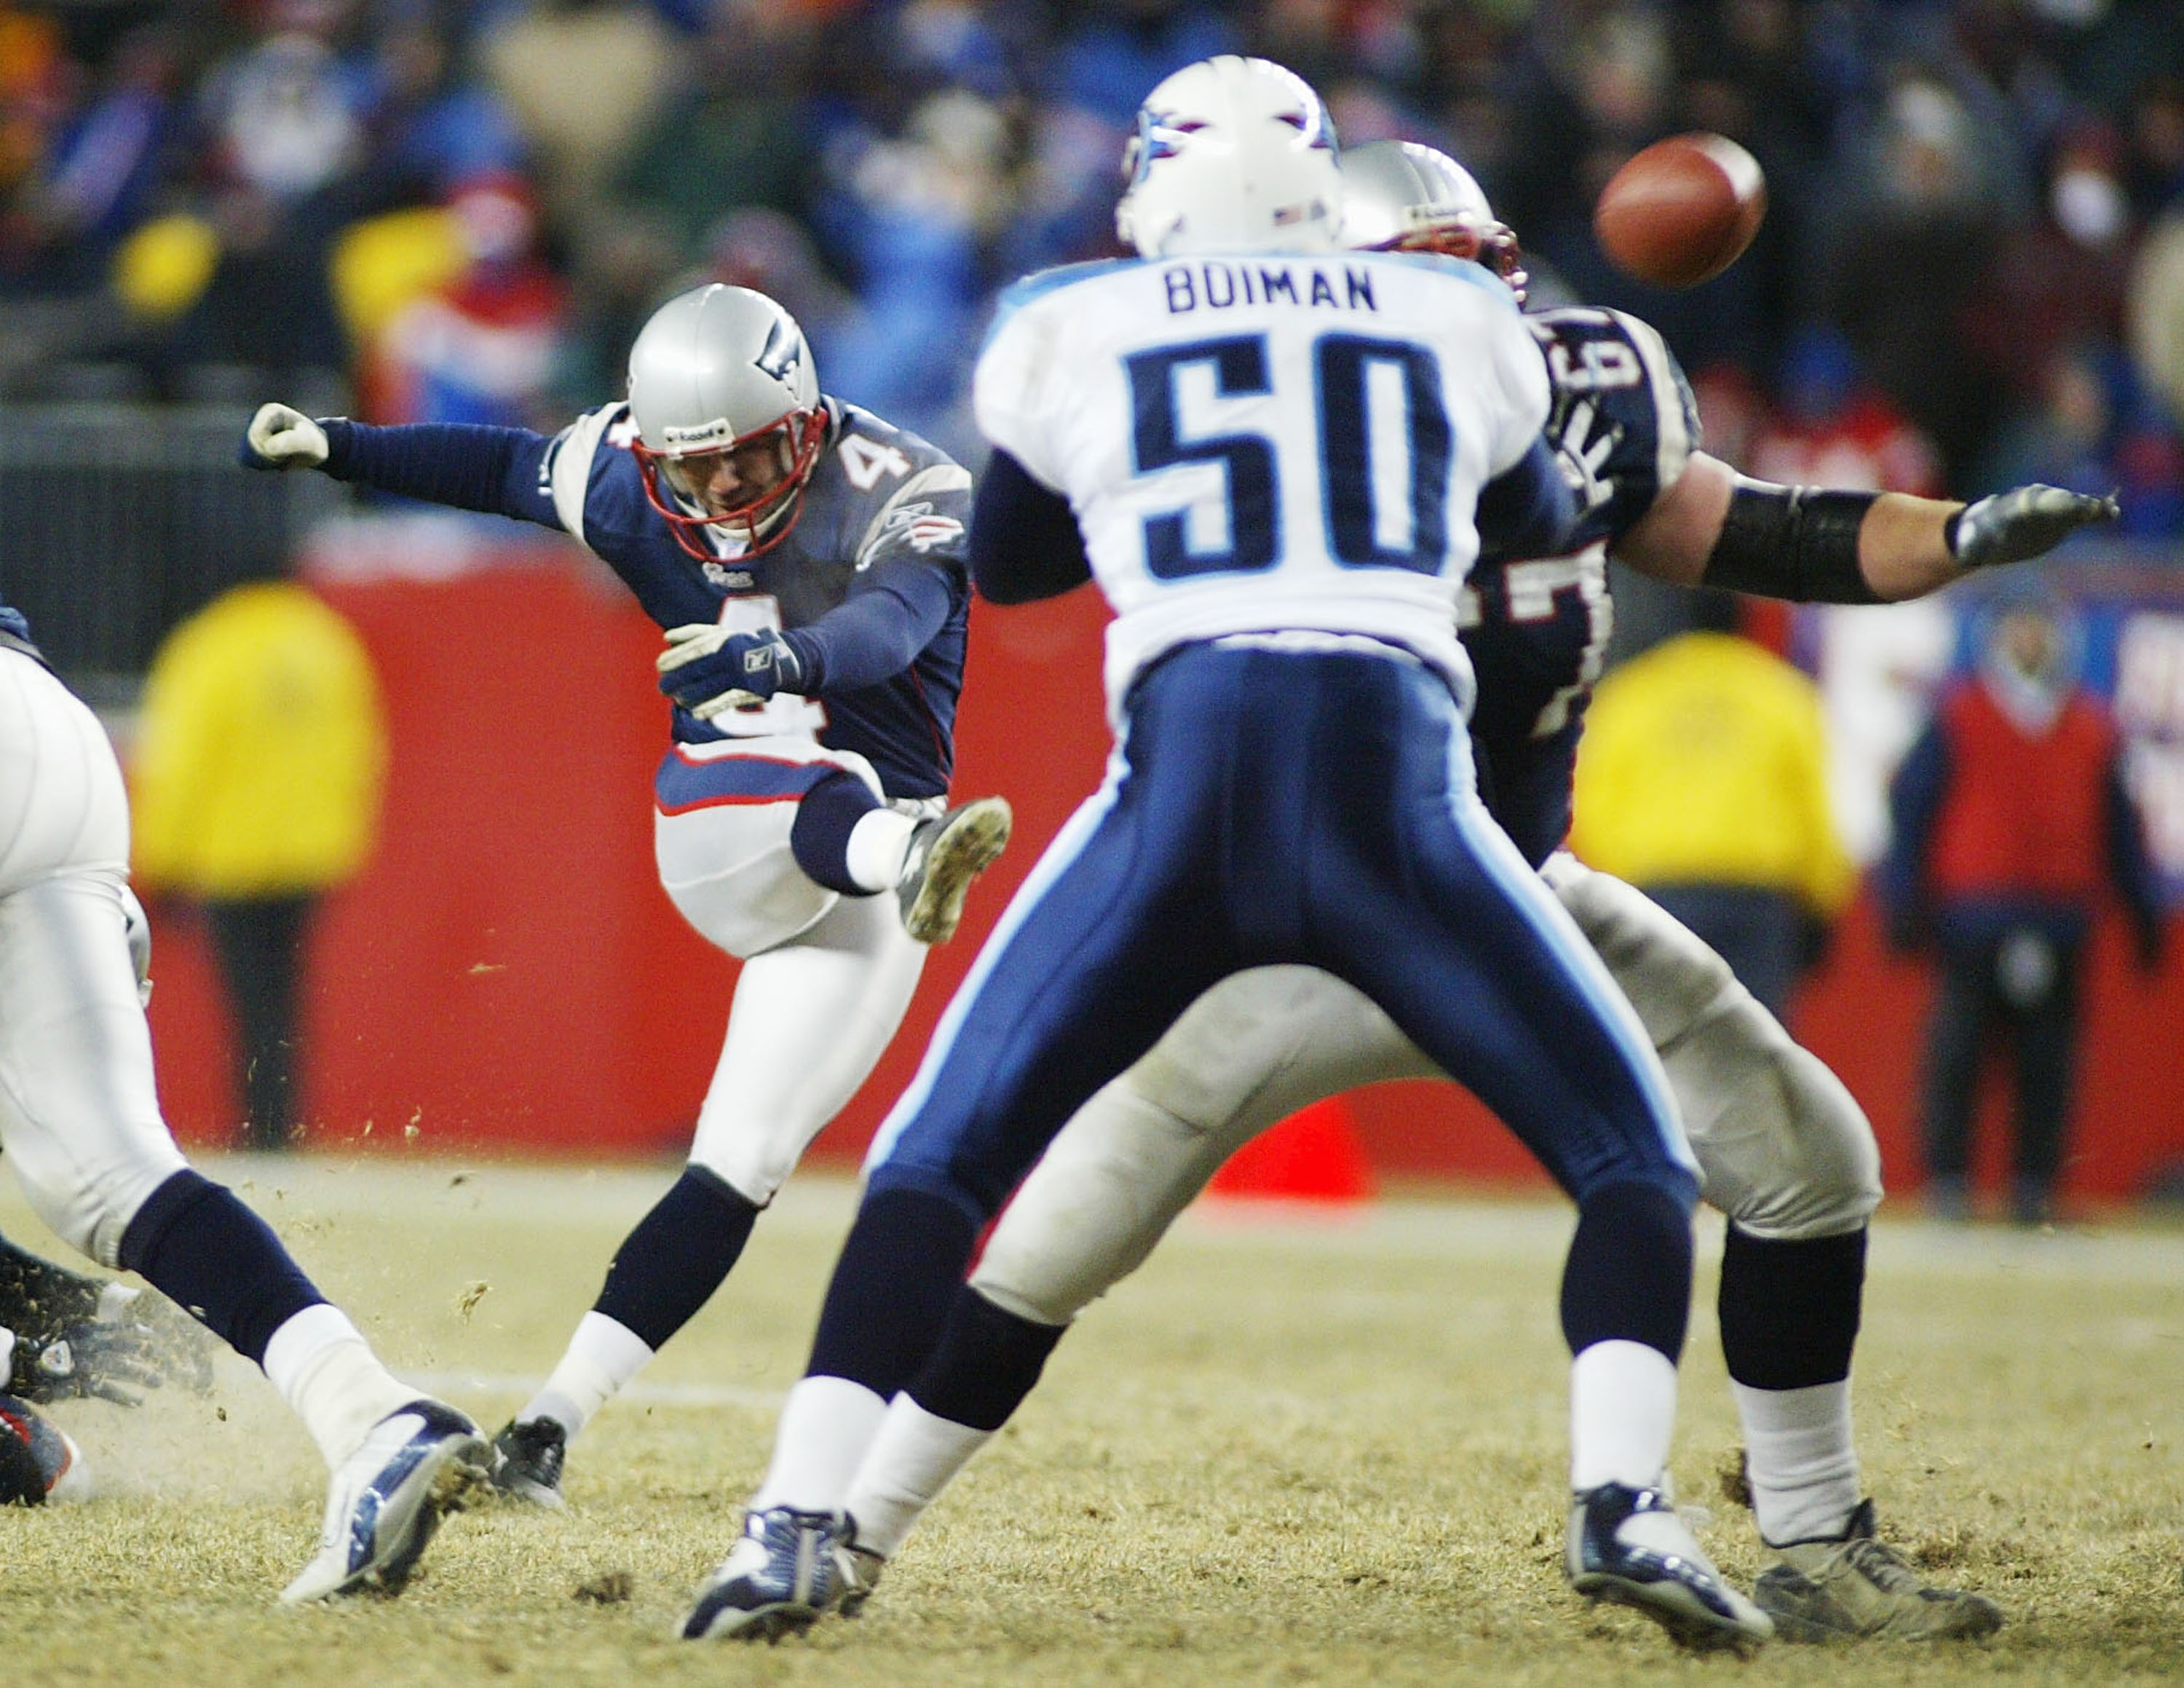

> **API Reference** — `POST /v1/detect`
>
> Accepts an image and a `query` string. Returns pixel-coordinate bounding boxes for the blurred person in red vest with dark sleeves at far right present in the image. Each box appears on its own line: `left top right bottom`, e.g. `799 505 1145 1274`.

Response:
1878 596 2162 1225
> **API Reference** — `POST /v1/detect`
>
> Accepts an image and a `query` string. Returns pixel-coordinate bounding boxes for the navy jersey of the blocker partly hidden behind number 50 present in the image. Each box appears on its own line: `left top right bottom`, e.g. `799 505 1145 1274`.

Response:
1459 308 1699 867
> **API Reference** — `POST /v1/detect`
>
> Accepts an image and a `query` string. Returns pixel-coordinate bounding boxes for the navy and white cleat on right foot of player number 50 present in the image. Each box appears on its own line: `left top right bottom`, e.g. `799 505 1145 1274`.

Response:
1564 1483 1773 1649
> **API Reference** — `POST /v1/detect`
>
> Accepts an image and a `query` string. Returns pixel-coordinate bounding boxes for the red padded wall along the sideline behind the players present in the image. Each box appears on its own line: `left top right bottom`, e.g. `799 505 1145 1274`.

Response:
153 552 2184 1197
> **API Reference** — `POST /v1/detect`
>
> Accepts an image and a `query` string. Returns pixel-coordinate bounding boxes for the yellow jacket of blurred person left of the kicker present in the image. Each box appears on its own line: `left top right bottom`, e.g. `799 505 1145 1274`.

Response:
131 581 387 900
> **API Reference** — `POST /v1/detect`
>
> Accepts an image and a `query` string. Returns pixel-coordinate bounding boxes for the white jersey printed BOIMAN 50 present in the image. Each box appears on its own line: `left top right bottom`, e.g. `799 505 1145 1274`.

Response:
974 253 1548 718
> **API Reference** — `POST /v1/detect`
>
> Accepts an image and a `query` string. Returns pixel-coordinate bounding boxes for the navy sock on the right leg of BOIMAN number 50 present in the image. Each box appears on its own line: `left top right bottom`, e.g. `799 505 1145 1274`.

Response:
1562 1179 1690 1360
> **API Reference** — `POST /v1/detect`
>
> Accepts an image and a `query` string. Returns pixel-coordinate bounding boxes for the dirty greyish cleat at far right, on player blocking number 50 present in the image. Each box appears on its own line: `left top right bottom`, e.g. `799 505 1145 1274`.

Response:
1752 1500 2003 1642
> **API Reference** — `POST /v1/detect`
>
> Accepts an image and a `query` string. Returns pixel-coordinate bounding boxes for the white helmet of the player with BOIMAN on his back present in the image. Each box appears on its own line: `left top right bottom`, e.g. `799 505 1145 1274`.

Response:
1114 52 1343 258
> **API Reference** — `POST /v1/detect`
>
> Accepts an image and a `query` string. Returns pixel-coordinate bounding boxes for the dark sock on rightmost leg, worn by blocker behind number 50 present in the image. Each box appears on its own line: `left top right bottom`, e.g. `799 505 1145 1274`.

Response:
1717 1225 1865 1389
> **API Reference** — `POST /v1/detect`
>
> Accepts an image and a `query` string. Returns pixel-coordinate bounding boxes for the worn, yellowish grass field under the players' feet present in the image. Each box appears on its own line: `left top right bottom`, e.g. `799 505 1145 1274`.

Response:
0 1160 2184 1688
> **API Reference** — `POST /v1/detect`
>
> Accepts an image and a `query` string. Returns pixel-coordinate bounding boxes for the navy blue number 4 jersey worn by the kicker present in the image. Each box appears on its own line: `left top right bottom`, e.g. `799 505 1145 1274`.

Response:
524 400 970 797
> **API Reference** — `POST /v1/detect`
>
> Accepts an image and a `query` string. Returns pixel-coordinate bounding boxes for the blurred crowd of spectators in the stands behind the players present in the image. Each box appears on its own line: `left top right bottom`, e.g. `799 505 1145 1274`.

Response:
0 0 2184 524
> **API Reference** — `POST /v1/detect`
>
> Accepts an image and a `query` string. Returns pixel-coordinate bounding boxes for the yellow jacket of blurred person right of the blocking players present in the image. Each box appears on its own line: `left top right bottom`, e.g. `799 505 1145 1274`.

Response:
1570 633 1856 915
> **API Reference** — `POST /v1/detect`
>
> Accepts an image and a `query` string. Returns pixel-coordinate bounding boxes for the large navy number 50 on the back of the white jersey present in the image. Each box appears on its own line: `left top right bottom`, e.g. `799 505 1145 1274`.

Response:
1123 334 1455 581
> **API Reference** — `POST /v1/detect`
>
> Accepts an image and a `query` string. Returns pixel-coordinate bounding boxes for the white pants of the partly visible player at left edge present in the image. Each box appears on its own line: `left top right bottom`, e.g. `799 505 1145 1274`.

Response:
0 651 183 1267
